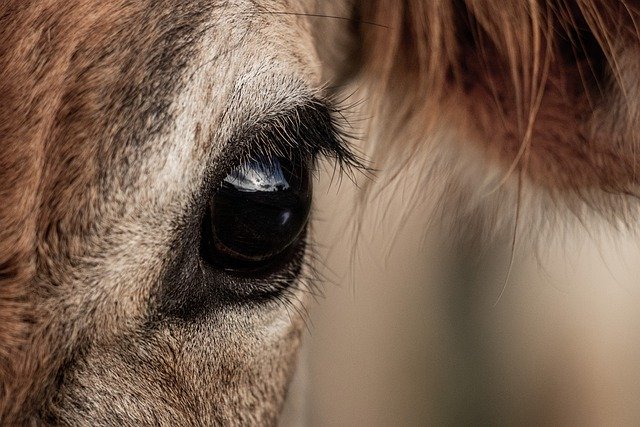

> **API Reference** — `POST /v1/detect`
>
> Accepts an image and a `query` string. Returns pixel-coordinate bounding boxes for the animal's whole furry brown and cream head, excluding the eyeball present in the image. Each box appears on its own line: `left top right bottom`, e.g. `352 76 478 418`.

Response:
0 0 640 426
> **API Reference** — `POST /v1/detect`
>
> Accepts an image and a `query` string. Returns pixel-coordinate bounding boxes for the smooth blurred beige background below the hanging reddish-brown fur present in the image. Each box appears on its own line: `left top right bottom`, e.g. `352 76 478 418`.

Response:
282 171 640 426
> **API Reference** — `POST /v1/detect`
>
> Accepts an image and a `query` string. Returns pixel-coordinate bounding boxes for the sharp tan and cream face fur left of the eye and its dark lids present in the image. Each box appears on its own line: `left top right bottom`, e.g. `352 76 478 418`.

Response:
0 0 318 425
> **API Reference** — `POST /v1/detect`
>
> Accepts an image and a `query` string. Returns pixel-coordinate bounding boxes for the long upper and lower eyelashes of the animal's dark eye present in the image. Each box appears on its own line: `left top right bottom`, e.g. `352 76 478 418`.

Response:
200 100 371 314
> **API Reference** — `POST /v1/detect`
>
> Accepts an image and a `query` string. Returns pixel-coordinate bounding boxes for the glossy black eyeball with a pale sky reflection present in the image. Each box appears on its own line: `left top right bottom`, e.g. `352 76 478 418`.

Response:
203 157 311 271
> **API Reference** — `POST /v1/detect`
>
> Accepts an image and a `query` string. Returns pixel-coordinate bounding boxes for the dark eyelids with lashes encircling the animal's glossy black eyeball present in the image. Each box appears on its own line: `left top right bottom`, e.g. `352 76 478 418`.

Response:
159 102 369 318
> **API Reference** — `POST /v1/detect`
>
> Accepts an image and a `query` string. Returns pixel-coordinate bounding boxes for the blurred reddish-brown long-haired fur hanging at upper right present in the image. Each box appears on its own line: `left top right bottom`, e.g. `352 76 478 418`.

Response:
356 0 640 231
